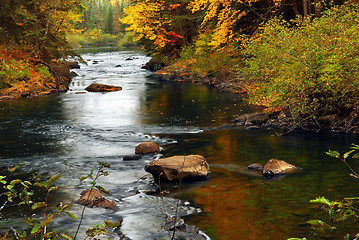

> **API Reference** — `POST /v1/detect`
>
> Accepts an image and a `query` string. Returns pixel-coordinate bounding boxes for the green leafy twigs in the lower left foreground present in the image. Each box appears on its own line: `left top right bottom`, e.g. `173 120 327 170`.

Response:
0 162 117 240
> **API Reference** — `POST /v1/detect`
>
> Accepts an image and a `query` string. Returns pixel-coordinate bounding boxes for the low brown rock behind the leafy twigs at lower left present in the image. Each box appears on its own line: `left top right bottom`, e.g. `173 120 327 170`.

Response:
77 189 116 210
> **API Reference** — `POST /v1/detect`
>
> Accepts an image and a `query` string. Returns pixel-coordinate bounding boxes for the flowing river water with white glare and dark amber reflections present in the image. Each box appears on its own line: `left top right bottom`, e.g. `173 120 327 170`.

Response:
0 51 359 240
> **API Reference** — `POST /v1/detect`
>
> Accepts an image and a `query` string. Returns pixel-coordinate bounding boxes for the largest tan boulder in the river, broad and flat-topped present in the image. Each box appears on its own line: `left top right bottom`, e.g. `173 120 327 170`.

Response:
145 155 209 181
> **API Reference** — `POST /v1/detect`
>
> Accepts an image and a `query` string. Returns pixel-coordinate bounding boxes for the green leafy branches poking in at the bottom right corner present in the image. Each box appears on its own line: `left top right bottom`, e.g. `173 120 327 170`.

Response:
288 144 359 240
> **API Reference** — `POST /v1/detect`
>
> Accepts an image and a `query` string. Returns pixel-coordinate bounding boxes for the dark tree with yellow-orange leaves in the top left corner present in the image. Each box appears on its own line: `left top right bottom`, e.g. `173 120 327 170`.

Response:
0 0 83 62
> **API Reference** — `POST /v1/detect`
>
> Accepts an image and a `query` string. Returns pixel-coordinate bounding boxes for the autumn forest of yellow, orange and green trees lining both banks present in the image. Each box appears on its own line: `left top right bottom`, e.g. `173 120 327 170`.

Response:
0 0 359 125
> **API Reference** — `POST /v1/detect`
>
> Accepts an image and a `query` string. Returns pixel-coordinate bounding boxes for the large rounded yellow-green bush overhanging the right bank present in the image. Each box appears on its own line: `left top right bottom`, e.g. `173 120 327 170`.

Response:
239 4 359 116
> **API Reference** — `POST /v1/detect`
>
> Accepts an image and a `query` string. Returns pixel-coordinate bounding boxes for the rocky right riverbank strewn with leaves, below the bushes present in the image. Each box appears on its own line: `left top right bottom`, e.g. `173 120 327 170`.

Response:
156 64 359 135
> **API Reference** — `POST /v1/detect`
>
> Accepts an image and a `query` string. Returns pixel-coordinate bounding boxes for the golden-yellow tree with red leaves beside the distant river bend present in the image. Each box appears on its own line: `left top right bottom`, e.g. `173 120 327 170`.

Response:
120 0 199 56
